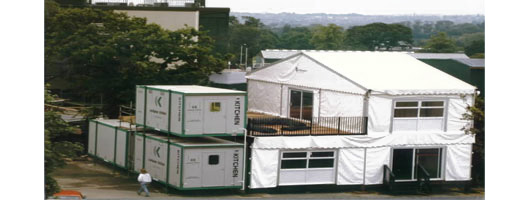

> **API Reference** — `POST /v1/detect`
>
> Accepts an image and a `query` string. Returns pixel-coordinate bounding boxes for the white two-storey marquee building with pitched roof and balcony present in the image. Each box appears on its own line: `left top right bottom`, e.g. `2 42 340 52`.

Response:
243 51 476 189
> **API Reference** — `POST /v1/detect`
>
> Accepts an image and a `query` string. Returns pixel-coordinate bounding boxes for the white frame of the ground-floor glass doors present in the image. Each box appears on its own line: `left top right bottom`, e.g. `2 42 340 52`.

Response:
390 146 447 182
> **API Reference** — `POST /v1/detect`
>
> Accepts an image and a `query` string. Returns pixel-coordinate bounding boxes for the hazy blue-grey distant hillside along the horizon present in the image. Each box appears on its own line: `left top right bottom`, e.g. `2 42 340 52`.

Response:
230 12 484 27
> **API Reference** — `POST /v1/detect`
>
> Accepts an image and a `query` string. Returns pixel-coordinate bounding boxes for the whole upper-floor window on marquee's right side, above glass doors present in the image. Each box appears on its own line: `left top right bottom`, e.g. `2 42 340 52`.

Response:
393 100 445 131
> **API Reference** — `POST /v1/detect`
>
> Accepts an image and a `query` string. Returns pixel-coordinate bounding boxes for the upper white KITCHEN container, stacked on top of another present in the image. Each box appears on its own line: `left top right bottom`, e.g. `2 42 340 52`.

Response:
136 85 247 137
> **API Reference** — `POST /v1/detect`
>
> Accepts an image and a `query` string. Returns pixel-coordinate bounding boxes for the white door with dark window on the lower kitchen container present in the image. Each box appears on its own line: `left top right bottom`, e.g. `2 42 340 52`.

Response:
198 152 225 187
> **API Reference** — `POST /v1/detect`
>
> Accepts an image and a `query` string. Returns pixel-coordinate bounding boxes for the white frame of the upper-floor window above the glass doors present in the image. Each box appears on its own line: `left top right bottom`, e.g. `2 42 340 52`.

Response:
390 98 448 132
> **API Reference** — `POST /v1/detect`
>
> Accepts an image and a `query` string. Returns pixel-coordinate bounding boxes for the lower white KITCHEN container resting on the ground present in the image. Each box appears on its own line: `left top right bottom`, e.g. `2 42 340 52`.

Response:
134 132 244 190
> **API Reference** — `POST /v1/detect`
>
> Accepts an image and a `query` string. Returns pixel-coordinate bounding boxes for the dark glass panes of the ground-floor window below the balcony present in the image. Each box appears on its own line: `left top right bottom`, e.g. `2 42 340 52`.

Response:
281 151 335 169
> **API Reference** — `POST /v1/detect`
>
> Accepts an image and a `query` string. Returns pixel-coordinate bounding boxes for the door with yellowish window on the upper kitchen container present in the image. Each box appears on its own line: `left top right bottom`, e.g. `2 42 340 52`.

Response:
203 99 227 134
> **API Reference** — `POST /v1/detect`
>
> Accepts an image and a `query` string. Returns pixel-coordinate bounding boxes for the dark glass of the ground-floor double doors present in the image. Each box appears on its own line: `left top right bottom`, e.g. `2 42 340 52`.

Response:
392 148 443 180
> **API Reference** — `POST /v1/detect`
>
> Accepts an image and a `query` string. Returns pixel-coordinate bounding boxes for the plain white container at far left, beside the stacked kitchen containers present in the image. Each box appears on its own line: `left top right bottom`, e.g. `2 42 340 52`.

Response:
88 119 136 169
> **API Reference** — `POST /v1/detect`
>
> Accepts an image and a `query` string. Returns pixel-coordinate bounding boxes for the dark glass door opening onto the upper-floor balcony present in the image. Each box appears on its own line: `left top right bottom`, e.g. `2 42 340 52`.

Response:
289 90 313 120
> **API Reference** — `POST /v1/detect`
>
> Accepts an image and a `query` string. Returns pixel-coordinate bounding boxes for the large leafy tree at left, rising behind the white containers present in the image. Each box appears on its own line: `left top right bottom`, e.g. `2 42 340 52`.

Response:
45 8 226 117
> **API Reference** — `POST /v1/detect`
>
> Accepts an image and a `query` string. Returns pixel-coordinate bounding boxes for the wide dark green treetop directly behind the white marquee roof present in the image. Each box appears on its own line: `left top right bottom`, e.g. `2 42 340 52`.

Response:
344 23 412 50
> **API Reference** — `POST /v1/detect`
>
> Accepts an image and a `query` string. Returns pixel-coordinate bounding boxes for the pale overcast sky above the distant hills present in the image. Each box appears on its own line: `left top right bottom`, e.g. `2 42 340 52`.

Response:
206 0 484 15
